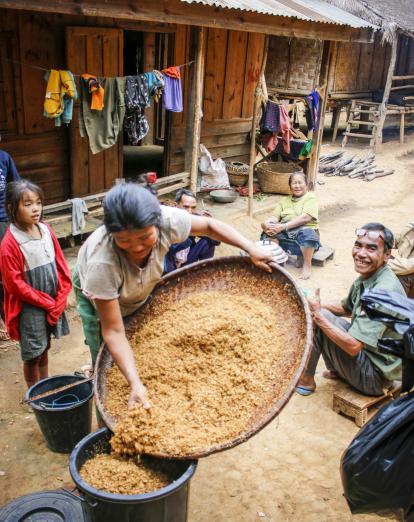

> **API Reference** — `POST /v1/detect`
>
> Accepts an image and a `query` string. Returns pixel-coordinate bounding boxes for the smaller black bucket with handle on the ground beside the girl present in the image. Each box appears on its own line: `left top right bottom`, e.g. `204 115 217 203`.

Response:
26 375 93 453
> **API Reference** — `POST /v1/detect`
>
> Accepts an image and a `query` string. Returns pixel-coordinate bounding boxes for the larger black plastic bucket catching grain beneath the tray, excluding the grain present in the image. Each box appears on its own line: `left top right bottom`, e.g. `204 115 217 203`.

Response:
69 428 197 522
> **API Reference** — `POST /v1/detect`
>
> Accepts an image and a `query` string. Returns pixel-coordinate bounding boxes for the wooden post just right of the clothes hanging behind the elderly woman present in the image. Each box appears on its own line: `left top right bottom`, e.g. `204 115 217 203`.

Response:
308 41 337 190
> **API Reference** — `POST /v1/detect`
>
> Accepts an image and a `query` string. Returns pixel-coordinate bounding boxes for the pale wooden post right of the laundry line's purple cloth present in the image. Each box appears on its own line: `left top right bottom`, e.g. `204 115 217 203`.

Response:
186 27 206 193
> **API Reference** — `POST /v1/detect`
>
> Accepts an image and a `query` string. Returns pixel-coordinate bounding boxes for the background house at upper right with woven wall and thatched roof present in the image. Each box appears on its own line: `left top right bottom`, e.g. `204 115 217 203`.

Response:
266 0 414 143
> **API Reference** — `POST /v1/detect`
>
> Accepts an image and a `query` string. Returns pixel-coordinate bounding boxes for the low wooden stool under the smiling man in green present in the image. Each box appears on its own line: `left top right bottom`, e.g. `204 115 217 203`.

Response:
332 381 401 428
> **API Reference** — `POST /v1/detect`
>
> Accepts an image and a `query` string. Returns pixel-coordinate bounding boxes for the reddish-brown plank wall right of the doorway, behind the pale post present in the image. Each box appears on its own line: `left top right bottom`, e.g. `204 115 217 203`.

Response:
168 27 264 174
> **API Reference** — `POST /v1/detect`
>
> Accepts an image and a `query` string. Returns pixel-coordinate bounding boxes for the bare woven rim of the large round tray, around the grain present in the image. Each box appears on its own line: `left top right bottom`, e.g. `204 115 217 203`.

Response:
94 256 312 459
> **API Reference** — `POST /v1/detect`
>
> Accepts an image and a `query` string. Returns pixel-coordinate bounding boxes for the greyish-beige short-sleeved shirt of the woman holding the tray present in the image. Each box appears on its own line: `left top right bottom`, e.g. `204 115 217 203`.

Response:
77 206 191 316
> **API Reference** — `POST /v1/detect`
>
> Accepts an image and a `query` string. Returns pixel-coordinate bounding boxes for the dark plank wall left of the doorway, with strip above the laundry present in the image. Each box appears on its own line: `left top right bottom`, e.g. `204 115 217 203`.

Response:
0 9 175 203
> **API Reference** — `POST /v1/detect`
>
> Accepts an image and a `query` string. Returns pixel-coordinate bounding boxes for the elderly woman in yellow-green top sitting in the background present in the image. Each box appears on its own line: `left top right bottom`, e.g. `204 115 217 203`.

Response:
262 172 320 279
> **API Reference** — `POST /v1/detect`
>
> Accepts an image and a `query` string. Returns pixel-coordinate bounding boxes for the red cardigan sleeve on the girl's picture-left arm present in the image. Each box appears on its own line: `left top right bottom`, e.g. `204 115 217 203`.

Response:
1 231 55 311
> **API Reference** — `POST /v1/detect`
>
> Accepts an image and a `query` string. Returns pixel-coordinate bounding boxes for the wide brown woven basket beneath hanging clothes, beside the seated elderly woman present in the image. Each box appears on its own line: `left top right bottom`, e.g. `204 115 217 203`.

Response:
256 161 303 194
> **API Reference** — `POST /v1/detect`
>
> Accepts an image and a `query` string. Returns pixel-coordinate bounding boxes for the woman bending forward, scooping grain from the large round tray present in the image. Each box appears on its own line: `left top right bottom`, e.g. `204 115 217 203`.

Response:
73 183 273 408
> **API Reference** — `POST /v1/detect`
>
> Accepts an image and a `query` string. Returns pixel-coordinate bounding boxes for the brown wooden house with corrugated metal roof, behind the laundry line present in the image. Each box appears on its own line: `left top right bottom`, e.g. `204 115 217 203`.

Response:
0 0 373 208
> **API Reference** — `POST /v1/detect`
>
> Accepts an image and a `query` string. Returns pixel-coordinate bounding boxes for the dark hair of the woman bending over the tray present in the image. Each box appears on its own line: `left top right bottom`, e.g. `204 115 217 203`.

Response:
103 183 161 232
